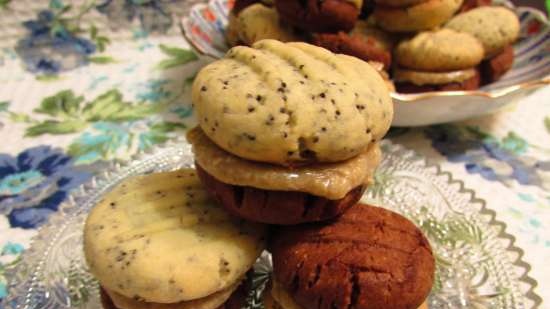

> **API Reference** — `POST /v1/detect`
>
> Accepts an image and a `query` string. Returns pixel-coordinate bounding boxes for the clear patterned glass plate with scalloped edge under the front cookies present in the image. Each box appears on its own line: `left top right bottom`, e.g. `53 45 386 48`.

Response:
5 141 541 309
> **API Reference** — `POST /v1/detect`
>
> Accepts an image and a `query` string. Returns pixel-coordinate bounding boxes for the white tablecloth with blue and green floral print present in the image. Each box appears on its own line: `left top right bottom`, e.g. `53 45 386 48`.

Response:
0 0 550 308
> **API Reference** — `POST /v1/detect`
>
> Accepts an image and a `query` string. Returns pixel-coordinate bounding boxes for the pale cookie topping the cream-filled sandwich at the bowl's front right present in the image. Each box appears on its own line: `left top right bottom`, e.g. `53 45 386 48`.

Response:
395 29 483 72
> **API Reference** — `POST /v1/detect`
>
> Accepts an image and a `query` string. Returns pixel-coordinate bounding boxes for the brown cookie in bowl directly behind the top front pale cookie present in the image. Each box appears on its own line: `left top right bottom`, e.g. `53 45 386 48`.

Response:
313 32 391 69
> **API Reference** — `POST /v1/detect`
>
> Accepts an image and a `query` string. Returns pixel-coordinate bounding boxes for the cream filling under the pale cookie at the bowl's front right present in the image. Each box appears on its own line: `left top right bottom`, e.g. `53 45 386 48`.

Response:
393 69 476 86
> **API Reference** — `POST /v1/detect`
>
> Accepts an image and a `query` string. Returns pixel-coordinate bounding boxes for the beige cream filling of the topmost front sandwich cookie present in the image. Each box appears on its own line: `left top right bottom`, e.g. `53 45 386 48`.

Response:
187 128 381 200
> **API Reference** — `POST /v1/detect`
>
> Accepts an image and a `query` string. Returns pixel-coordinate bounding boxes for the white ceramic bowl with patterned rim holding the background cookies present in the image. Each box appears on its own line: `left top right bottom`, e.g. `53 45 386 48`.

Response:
181 0 550 126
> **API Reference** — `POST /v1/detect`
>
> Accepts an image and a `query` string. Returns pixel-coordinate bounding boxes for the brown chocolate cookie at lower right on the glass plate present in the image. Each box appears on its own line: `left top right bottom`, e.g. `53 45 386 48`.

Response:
270 205 435 309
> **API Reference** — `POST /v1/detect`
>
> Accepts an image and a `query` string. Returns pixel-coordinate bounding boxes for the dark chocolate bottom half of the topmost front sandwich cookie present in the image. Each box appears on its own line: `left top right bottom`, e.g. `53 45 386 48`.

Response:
196 165 365 225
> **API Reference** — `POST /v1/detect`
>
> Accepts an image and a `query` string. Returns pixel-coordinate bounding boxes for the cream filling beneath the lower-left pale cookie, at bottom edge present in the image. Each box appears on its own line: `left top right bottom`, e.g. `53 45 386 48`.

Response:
105 281 241 309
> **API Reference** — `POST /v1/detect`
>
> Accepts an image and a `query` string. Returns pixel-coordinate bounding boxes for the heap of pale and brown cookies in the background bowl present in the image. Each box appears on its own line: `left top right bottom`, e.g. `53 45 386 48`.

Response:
226 0 520 93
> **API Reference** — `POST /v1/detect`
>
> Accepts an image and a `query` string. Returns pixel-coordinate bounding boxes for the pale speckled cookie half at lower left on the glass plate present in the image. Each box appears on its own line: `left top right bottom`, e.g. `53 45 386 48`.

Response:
84 169 264 303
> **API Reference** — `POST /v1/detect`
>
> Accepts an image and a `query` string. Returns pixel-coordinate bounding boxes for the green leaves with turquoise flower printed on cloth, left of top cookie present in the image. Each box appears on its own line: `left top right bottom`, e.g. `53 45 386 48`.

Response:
4 89 191 164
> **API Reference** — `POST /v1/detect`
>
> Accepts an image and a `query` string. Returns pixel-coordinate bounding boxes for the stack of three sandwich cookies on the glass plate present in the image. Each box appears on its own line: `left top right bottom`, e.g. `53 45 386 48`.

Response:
84 40 435 309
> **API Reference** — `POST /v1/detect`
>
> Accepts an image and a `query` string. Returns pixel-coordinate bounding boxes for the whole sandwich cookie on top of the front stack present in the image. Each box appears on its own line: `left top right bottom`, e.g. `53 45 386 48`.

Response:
188 40 393 224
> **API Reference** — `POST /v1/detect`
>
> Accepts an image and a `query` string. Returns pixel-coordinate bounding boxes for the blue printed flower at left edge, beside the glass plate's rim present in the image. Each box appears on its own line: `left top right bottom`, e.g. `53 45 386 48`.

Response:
0 146 91 228
